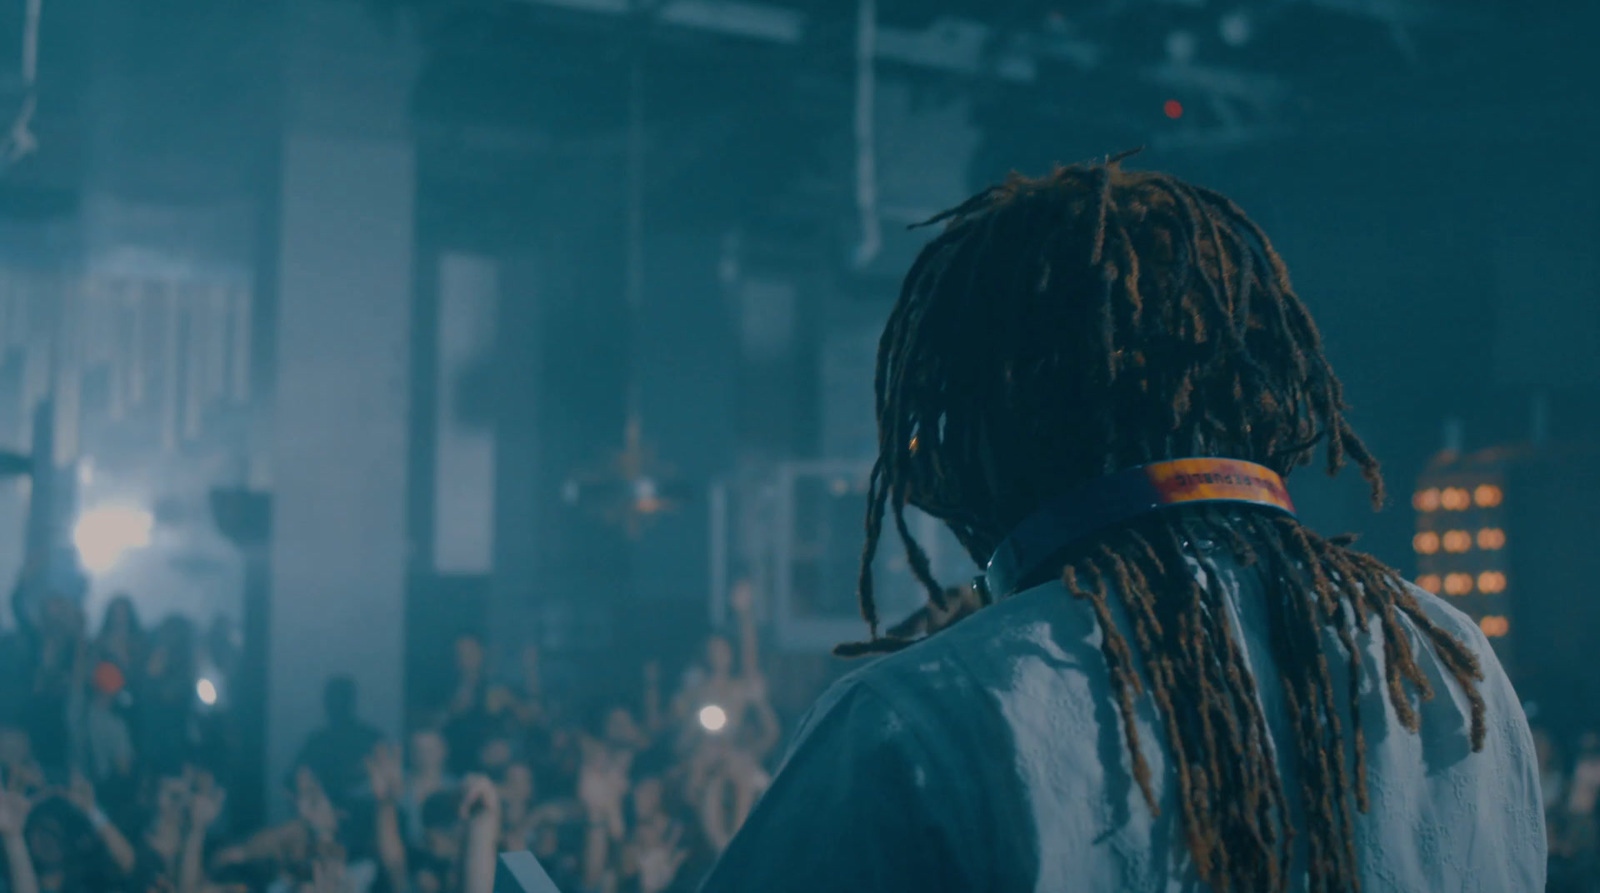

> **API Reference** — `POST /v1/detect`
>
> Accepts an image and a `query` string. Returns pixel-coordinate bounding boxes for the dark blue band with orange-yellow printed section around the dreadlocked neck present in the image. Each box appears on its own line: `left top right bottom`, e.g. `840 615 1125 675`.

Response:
982 459 1294 599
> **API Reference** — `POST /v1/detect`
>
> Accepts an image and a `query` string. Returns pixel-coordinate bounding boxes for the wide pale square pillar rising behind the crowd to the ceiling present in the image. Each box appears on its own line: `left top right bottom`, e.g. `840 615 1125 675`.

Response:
267 0 416 813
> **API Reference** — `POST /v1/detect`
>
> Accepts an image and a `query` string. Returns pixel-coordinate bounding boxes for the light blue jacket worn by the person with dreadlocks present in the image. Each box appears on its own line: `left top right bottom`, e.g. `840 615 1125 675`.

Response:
702 537 1546 893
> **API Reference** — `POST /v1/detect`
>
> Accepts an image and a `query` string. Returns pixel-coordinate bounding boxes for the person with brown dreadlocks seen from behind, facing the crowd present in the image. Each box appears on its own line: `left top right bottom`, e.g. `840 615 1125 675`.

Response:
706 158 1546 893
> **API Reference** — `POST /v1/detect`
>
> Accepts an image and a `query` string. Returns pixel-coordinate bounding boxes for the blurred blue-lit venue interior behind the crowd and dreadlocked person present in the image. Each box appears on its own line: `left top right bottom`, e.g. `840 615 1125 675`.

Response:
0 0 1600 888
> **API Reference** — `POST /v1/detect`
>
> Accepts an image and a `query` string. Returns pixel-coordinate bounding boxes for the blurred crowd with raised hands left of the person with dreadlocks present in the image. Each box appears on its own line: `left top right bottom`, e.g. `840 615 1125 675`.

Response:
0 576 779 893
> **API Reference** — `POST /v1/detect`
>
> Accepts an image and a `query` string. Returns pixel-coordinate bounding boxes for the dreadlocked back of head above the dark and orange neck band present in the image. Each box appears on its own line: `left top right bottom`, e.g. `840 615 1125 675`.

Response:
877 162 1379 559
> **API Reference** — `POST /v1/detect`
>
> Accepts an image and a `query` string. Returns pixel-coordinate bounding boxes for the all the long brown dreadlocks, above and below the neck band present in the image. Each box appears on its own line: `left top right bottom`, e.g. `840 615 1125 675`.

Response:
838 157 1485 891
